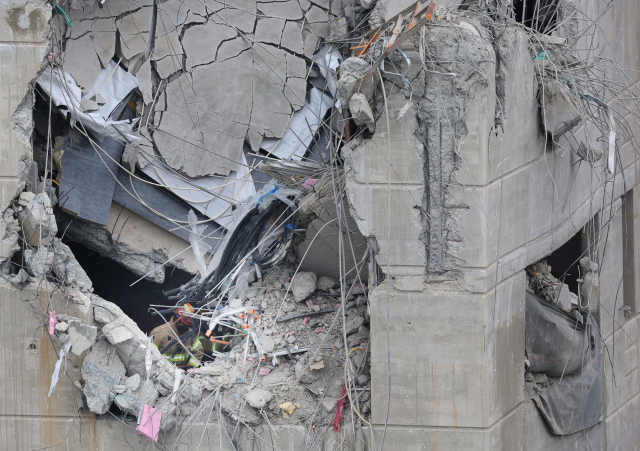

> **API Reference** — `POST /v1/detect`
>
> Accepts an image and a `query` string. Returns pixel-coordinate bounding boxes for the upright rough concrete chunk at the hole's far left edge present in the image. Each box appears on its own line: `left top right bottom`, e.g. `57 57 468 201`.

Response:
18 192 58 247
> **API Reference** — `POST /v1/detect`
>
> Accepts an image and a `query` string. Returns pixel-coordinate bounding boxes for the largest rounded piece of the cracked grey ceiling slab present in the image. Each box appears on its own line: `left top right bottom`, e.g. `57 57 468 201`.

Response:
153 58 253 177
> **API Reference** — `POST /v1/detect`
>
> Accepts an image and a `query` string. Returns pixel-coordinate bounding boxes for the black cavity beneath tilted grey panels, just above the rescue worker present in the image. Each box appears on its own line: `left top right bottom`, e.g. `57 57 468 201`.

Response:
65 240 193 334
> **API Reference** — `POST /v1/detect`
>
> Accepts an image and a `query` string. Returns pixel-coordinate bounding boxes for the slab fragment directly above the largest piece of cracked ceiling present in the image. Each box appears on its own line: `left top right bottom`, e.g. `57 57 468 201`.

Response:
182 20 238 71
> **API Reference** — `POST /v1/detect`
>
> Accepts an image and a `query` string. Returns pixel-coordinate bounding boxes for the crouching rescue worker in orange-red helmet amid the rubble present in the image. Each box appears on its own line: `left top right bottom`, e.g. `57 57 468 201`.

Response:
151 304 213 368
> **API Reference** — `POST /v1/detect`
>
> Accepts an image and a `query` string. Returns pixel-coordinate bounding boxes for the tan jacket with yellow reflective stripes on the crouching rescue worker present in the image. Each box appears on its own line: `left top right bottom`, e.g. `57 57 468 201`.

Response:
151 317 213 367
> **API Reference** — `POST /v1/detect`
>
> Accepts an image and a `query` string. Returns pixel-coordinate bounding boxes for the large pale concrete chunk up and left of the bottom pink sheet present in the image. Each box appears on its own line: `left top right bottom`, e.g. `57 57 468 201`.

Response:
82 341 126 415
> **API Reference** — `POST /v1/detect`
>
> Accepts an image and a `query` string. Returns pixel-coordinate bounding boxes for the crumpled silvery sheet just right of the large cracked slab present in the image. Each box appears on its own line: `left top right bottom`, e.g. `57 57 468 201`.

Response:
262 88 333 160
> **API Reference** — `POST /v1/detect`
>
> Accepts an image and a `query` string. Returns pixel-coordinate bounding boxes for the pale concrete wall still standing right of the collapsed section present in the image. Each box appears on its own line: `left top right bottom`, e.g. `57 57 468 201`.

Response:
347 2 640 450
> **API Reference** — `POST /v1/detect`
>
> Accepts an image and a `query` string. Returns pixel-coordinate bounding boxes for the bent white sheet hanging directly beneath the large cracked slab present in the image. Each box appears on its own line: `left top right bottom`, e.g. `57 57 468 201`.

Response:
143 154 255 227
